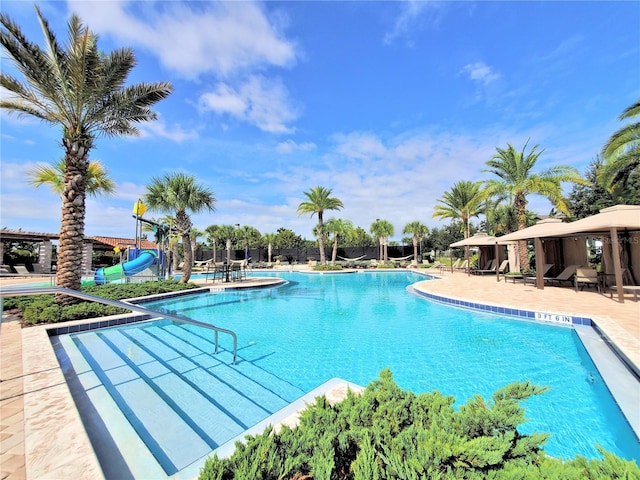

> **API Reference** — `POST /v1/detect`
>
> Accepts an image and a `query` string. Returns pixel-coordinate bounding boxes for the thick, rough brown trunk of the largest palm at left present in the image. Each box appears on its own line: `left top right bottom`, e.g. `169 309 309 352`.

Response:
56 144 88 305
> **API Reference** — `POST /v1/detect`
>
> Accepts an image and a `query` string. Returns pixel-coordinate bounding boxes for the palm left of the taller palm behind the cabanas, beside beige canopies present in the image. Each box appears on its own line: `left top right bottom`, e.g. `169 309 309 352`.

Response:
433 180 486 265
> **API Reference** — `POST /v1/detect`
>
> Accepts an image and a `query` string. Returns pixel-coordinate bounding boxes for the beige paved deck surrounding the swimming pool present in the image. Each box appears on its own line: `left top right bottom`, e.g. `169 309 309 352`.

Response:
0 267 640 480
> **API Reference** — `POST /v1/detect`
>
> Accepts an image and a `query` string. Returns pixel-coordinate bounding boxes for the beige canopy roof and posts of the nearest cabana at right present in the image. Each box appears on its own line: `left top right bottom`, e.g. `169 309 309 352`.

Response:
498 205 640 303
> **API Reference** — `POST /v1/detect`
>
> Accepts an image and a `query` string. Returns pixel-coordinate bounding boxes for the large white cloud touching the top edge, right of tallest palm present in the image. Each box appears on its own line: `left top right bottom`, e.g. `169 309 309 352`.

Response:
69 1 297 78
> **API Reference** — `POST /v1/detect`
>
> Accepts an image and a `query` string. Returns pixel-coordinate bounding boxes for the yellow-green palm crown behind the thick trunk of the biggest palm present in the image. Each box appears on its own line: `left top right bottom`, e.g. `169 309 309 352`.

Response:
27 158 116 196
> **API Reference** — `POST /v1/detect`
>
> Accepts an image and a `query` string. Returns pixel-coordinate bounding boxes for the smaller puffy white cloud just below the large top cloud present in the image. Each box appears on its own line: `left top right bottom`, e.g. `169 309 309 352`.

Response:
200 75 298 133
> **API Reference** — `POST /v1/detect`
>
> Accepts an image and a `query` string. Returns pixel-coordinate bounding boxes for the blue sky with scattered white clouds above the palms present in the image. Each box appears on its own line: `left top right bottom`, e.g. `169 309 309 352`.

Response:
0 0 640 240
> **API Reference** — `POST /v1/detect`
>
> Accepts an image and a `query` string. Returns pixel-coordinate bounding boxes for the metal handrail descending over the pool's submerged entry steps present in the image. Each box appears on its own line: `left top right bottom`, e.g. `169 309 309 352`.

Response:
0 287 238 365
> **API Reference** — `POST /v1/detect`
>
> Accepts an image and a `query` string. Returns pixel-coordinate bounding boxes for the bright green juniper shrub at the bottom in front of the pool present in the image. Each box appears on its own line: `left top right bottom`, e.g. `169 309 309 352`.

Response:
200 370 640 480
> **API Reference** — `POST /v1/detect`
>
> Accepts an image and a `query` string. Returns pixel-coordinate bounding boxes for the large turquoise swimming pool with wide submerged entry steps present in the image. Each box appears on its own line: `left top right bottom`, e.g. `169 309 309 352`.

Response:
55 272 640 474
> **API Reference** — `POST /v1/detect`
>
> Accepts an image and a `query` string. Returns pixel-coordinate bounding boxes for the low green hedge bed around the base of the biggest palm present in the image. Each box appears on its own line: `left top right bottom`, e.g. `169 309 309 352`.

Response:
4 280 197 325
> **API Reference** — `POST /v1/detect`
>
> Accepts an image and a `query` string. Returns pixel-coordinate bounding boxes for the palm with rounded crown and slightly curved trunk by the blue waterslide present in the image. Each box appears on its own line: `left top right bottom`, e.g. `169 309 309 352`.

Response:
144 173 216 283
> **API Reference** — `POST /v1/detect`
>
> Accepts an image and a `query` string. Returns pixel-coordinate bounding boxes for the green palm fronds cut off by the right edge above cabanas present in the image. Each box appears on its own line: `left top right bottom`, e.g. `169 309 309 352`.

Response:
598 100 640 196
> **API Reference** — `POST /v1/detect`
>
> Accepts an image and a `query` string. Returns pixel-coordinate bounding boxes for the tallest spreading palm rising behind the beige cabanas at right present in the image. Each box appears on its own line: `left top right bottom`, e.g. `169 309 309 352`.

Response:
483 141 585 270
